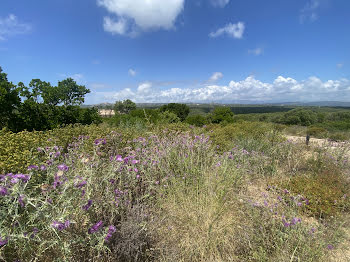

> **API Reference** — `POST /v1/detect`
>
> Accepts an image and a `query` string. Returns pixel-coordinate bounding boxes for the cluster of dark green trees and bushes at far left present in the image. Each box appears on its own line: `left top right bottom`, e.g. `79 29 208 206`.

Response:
0 67 101 132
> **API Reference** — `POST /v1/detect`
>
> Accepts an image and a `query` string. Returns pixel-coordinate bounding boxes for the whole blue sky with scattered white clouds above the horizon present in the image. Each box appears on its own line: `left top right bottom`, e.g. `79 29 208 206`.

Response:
0 0 350 104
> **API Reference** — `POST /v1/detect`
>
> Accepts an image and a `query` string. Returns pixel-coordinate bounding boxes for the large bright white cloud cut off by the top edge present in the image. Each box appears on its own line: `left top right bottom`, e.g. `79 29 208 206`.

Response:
97 0 185 36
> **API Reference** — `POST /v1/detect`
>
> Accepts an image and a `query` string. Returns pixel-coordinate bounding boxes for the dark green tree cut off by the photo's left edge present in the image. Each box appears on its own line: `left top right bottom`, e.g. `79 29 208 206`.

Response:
0 67 21 129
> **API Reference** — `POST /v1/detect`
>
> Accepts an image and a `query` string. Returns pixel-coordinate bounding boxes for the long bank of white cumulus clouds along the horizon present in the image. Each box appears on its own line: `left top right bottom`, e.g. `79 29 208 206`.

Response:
108 76 350 103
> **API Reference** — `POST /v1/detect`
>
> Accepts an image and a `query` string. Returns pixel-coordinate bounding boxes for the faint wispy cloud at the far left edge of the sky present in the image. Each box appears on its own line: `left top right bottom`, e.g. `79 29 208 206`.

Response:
0 14 32 40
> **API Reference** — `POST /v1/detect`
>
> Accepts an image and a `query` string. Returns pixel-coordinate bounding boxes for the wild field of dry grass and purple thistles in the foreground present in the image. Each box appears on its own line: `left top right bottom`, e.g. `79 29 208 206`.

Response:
0 121 350 261
